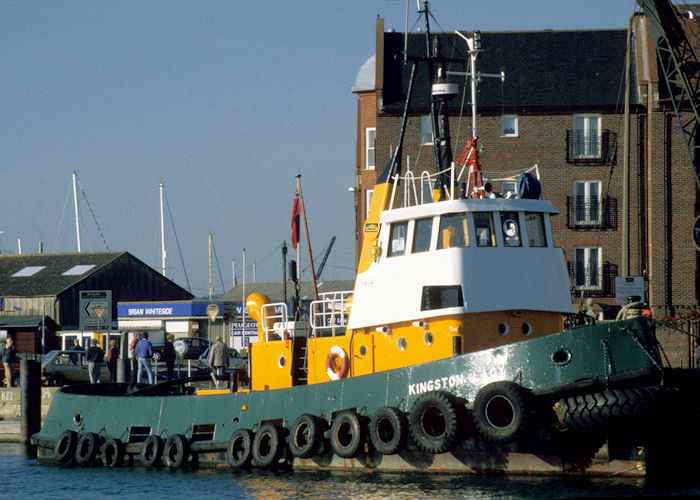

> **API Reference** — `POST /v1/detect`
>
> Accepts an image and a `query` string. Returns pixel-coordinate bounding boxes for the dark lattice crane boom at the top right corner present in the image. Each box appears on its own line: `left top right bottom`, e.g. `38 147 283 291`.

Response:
637 0 700 191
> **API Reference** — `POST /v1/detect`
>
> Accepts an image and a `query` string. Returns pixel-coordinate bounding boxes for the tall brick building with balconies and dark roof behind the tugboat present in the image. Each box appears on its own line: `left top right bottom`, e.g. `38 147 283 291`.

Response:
352 15 699 366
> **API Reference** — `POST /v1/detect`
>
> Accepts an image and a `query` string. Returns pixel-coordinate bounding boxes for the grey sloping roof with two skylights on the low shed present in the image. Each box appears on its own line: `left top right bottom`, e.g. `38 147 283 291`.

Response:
0 251 127 297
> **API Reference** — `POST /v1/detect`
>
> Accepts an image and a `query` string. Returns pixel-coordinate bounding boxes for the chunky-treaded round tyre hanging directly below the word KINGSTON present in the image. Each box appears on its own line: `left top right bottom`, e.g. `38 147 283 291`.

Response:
408 391 460 454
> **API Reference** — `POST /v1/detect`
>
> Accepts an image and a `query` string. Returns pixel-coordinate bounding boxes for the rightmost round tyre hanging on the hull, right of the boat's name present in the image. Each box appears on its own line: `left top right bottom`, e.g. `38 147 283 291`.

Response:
472 381 528 443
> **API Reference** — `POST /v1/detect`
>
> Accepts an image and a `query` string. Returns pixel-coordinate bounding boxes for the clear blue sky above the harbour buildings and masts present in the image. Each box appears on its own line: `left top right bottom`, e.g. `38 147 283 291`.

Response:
0 0 635 295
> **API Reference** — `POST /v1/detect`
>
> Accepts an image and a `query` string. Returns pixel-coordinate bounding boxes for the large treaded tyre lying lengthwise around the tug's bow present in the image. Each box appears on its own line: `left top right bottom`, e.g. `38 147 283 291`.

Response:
555 386 676 429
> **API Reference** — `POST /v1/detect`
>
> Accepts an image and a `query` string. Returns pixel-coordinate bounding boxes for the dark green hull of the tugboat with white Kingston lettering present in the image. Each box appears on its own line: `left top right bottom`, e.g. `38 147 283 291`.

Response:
33 319 687 474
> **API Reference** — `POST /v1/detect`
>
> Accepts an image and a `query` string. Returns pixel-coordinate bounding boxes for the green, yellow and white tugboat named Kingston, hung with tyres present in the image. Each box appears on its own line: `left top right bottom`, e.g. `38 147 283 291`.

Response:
32 1 699 475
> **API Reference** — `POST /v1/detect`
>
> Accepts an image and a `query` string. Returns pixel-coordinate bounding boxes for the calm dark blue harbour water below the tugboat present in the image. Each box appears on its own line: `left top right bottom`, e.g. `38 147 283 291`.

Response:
0 444 700 500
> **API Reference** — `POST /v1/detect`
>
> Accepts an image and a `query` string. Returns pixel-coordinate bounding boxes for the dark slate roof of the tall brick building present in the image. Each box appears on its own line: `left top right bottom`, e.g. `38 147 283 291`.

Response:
382 29 626 112
